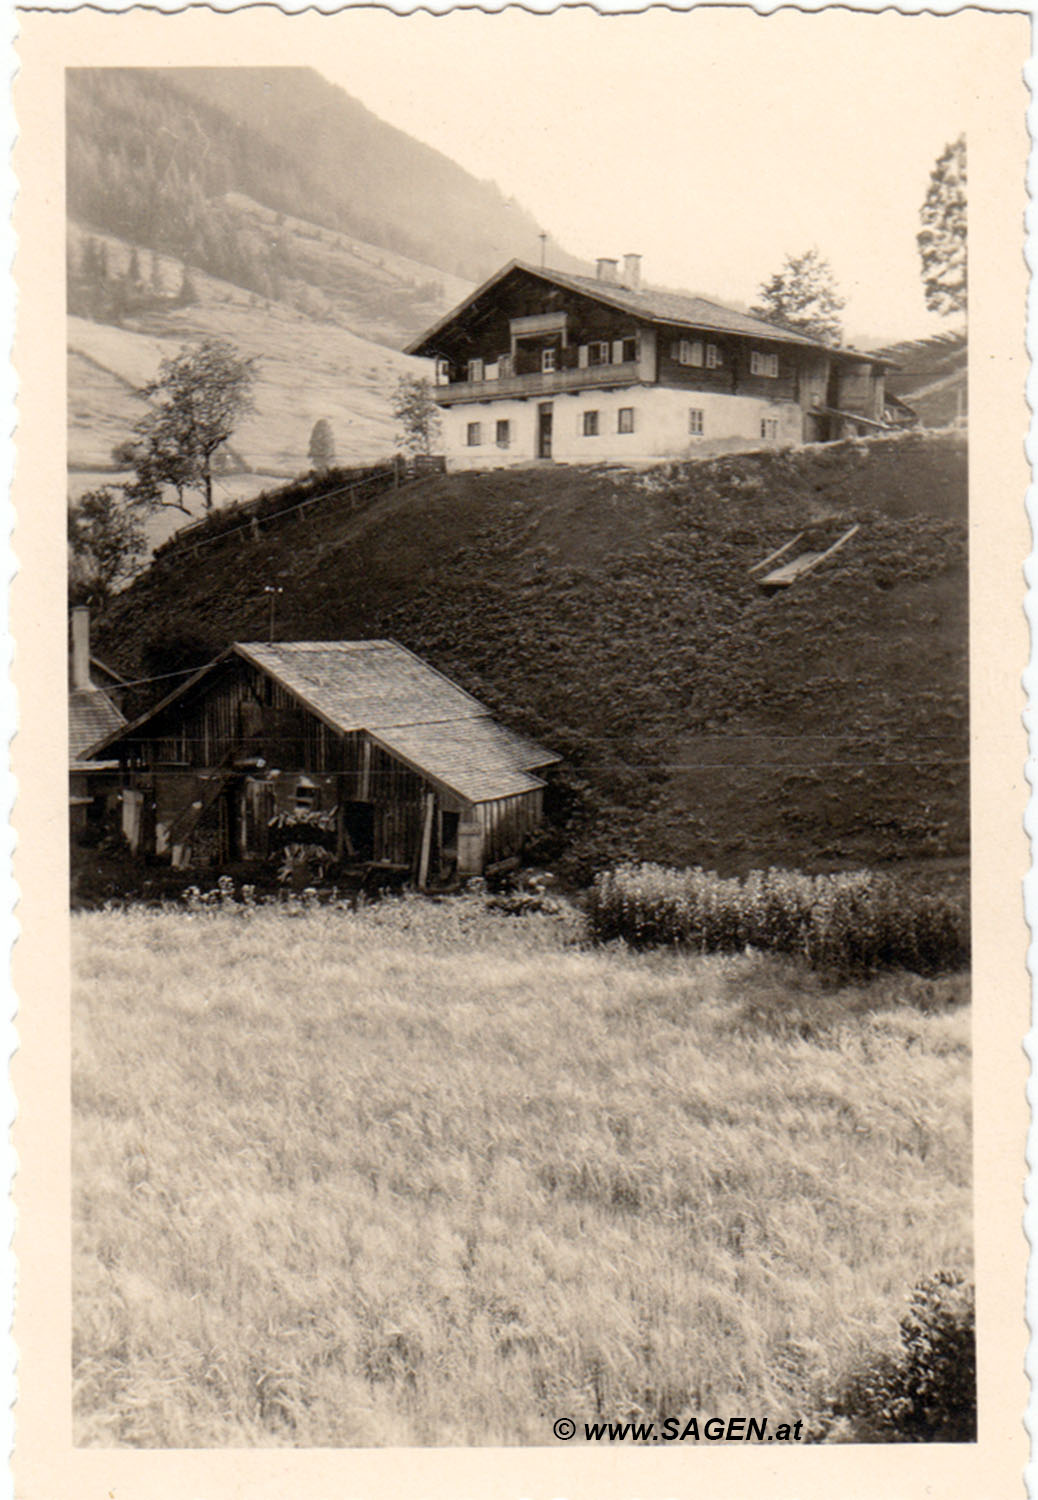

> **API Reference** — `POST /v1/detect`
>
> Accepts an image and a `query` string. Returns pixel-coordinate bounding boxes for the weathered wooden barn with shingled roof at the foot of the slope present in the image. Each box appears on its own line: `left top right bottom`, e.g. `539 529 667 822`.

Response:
92 641 558 885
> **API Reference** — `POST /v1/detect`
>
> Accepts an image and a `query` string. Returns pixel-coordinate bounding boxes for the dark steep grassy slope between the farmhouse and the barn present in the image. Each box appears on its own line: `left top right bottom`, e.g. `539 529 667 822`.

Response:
98 434 969 879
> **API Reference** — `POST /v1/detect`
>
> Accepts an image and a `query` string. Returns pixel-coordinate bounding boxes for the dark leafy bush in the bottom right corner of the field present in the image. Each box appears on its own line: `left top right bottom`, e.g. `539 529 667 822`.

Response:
833 1271 977 1443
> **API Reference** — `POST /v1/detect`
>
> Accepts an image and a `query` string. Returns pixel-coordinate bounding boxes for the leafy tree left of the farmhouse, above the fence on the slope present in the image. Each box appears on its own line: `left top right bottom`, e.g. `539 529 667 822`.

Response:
116 339 257 515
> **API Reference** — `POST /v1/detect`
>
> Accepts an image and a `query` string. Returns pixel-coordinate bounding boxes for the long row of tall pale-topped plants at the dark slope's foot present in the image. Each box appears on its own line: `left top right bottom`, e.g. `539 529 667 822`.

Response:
588 864 969 975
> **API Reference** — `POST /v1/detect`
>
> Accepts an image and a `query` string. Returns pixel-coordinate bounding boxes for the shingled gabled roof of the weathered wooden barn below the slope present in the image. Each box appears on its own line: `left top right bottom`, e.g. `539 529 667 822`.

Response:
95 641 560 803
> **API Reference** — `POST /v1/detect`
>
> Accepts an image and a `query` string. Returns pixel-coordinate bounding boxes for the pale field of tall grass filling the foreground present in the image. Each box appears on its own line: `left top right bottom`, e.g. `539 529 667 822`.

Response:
74 899 971 1448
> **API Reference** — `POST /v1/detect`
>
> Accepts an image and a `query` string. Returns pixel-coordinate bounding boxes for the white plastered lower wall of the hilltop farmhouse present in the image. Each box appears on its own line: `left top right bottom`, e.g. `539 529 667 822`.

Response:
444 386 804 470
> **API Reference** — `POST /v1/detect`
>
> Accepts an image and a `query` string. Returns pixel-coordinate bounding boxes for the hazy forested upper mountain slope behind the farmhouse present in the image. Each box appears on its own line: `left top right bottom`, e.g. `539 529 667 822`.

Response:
66 68 579 296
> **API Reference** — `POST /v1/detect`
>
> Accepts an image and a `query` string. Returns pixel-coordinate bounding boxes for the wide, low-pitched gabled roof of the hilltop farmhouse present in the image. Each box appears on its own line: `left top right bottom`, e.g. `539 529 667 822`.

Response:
405 261 890 365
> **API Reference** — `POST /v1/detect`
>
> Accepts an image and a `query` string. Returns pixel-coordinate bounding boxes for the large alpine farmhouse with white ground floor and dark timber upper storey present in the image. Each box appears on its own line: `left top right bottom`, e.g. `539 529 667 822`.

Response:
407 255 890 470
